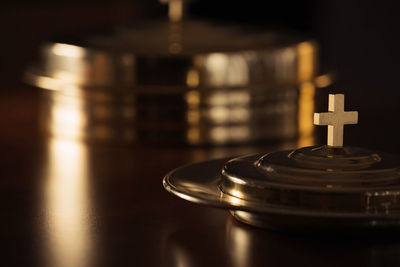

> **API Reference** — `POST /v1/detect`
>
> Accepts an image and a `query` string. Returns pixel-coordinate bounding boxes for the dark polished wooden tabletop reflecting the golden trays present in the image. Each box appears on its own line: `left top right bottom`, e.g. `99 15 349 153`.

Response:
0 90 400 267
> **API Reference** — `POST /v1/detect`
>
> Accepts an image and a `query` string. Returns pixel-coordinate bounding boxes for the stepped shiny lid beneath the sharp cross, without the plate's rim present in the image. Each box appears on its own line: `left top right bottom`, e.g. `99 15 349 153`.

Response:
220 146 400 215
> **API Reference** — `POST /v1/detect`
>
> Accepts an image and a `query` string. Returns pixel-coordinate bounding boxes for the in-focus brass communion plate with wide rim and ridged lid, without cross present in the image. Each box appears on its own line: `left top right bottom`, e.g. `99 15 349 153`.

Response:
163 146 400 229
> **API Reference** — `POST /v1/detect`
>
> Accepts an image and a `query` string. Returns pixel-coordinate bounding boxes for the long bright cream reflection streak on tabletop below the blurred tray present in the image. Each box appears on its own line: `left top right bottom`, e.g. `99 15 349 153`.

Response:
44 138 92 267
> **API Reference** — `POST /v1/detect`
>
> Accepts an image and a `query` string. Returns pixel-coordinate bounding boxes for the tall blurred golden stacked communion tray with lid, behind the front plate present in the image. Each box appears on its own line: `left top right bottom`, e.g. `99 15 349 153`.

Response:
26 15 317 145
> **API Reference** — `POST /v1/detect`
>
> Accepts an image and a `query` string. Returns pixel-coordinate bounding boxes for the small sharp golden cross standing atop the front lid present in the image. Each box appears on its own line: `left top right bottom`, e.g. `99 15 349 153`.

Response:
314 94 358 147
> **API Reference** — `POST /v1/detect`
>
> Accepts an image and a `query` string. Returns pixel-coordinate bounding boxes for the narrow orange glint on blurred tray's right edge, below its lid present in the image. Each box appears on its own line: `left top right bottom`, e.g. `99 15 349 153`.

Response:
297 82 315 147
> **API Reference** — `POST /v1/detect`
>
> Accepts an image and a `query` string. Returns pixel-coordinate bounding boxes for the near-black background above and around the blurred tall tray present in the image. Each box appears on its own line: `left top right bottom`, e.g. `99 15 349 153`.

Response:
0 0 400 152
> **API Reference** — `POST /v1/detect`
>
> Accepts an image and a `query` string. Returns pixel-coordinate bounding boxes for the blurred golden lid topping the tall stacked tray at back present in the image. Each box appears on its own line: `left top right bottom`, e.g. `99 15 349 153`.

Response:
26 21 317 91
